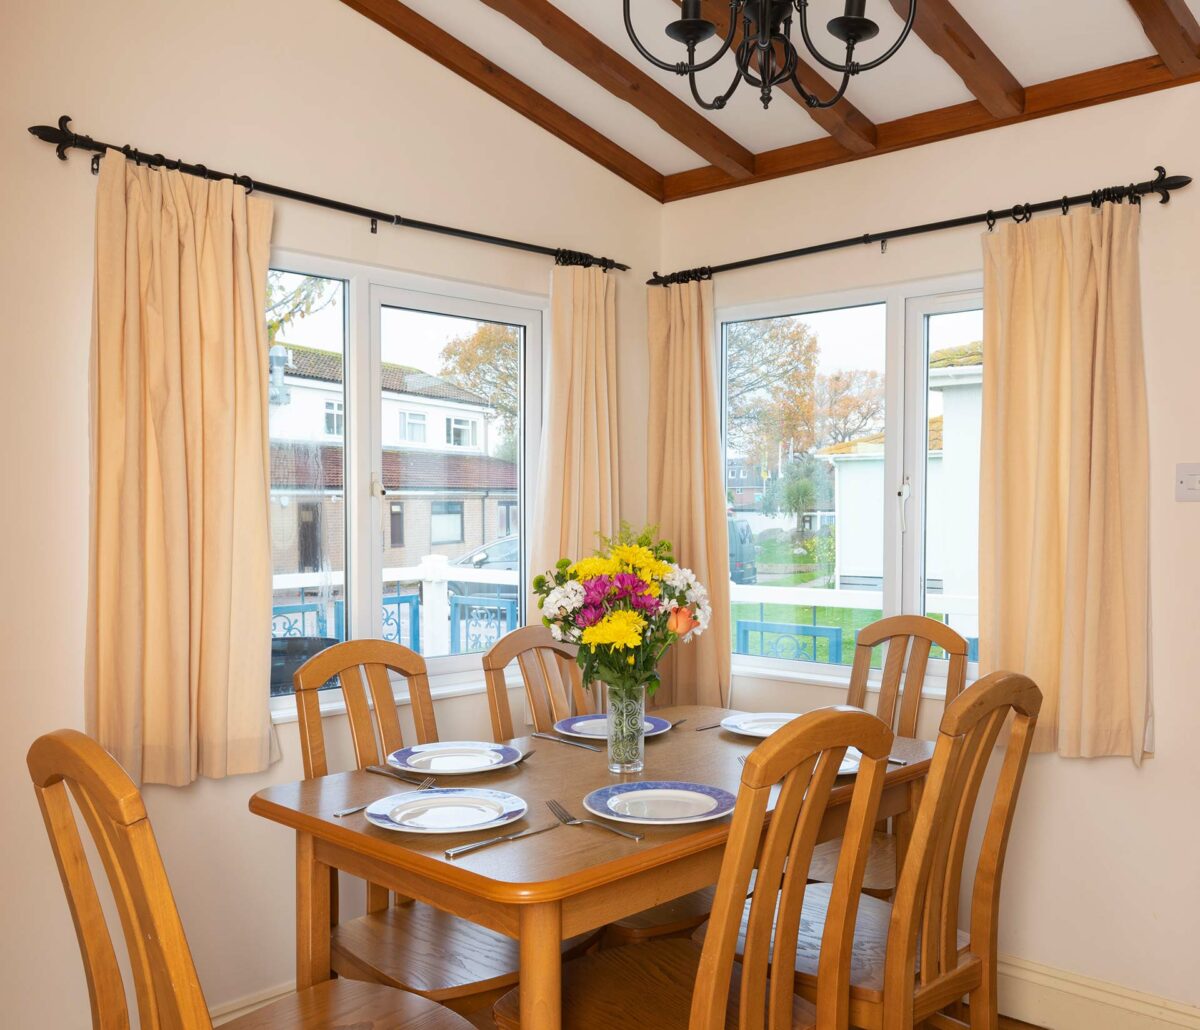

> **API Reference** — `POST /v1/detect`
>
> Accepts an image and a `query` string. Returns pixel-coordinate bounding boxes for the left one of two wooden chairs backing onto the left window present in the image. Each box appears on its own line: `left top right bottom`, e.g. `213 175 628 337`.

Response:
293 640 588 1012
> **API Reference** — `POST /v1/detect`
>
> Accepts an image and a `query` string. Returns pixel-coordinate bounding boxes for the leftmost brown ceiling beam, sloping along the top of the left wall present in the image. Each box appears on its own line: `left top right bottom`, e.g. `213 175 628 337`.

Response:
342 0 667 200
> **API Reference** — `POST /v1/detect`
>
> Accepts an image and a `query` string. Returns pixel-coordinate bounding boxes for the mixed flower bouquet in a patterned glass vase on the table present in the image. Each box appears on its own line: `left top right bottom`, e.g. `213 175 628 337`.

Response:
533 525 713 773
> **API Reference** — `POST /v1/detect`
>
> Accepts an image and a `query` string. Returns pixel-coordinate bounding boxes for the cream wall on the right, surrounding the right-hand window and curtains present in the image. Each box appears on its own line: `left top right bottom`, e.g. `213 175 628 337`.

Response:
661 85 1200 1013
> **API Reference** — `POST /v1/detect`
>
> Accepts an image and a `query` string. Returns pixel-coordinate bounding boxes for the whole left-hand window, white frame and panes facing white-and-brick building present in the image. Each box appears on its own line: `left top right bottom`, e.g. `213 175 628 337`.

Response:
266 253 544 706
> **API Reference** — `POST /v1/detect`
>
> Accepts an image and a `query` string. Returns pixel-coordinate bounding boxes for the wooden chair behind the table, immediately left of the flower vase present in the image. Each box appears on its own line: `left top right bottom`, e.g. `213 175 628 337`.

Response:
484 625 714 946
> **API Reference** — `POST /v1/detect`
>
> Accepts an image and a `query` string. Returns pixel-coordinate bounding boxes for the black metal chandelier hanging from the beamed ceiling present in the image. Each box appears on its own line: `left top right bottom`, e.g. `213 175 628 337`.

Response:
625 0 917 110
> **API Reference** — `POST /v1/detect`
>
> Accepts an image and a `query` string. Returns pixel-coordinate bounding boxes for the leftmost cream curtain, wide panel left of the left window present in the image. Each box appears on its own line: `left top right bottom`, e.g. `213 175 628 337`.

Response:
86 151 274 785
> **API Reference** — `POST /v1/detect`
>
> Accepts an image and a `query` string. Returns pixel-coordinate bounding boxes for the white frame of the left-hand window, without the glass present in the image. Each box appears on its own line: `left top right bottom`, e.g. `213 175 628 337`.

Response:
270 248 550 723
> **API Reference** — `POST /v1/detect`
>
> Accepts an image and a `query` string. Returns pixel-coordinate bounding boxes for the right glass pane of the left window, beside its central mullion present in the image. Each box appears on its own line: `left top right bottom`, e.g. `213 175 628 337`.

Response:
379 305 524 657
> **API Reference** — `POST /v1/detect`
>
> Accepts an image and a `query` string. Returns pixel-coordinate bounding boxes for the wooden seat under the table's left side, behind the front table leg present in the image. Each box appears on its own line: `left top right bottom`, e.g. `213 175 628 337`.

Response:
330 902 595 1001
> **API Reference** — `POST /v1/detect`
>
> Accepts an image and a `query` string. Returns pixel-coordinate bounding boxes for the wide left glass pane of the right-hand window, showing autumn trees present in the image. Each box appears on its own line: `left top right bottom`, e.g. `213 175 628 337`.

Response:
724 304 887 665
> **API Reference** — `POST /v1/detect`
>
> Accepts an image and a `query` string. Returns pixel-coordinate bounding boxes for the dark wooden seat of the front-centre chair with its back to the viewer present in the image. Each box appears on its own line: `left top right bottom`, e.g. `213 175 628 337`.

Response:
492 938 816 1030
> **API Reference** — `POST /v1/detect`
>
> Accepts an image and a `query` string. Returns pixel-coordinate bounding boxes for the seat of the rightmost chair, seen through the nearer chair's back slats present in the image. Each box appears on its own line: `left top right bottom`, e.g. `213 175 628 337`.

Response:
692 884 971 1002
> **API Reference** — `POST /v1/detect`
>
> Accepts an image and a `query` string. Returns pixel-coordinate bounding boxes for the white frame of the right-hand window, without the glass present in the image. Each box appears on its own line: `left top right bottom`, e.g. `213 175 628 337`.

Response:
713 271 983 696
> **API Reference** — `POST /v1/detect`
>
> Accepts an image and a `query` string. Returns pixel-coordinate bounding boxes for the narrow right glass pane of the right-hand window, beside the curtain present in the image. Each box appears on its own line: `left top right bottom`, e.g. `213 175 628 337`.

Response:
924 309 983 660
